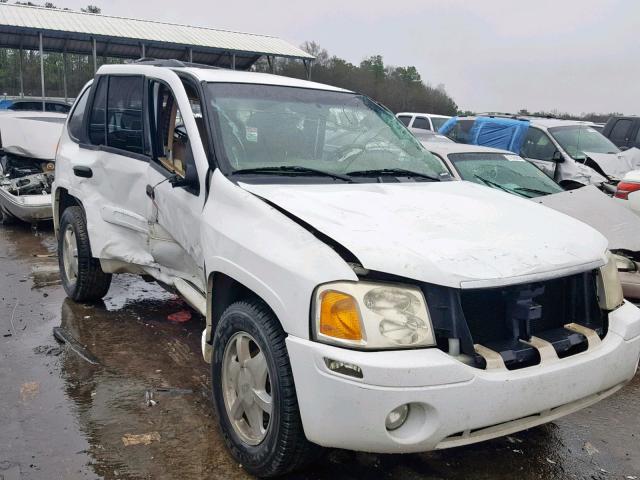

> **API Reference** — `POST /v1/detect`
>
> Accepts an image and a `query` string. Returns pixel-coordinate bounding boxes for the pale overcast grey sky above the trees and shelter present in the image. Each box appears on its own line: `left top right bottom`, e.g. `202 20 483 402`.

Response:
54 0 640 114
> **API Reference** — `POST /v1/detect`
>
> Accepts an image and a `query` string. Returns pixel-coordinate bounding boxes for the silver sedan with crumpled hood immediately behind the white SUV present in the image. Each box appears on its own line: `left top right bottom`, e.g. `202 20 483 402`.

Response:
423 141 640 300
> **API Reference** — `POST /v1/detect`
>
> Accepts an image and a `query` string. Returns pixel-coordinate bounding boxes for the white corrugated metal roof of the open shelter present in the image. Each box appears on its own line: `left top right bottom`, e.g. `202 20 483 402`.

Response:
0 4 314 59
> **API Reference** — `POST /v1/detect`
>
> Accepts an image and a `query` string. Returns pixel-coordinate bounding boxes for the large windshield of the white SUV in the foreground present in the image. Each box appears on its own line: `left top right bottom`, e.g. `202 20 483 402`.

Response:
206 83 446 181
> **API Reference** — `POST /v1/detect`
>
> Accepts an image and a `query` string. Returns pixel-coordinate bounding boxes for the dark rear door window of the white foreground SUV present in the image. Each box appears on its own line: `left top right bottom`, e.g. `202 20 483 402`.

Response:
107 76 144 154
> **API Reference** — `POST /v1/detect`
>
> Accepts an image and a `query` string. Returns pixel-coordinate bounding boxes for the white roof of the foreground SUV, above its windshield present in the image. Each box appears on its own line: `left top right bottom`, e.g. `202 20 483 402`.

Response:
97 64 353 93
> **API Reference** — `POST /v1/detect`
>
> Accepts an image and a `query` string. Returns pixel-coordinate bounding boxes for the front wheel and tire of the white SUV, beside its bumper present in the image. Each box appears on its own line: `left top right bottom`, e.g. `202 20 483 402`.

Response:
211 301 321 478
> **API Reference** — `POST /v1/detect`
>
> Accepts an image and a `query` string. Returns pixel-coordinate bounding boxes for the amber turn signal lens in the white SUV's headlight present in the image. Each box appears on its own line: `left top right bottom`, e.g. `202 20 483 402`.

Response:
320 290 362 340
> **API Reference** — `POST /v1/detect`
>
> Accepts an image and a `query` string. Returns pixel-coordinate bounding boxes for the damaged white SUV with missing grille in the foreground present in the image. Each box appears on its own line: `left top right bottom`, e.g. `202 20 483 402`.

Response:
54 62 640 476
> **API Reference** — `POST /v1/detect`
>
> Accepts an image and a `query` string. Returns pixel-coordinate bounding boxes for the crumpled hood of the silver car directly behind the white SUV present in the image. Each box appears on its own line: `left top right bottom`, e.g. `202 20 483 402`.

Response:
532 185 640 252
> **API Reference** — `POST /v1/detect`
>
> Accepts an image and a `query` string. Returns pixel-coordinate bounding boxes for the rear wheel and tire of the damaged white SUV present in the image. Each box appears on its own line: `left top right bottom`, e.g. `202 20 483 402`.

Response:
58 207 111 302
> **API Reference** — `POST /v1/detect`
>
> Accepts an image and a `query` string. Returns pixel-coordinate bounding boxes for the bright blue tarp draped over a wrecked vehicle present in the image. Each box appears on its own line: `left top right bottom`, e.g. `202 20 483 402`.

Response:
439 117 529 153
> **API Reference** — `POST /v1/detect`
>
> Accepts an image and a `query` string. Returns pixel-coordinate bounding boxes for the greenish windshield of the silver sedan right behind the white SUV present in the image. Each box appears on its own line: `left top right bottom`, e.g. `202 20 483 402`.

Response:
448 153 563 198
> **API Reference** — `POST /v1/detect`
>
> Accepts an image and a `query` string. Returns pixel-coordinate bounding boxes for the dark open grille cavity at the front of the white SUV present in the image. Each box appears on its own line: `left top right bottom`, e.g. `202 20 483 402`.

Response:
436 271 607 370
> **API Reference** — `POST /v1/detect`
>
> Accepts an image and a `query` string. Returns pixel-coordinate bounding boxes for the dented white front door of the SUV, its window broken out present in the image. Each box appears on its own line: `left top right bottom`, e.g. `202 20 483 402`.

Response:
147 72 208 292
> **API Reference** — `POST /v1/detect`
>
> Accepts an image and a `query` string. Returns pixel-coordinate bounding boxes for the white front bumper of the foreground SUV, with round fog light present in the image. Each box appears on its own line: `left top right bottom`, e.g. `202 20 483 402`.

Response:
287 303 640 453
